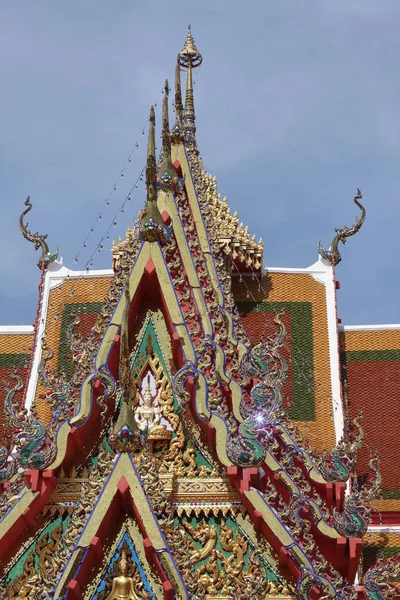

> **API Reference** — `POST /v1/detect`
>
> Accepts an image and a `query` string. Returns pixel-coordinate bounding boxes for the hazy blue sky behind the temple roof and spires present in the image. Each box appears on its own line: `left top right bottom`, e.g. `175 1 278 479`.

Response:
0 0 400 324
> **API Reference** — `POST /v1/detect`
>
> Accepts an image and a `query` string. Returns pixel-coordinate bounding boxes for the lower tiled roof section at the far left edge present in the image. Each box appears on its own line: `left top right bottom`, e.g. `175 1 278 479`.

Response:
0 327 33 445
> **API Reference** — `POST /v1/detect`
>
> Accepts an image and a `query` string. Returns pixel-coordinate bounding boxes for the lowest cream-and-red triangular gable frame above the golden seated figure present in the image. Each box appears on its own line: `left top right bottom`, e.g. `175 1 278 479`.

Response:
55 453 186 600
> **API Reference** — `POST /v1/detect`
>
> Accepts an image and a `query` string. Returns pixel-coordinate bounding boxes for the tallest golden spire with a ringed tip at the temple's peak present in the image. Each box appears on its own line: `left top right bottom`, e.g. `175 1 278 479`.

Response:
179 25 203 146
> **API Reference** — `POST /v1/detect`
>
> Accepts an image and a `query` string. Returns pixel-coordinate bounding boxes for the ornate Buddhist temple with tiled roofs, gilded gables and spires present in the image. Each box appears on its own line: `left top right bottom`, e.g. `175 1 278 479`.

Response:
0 28 400 600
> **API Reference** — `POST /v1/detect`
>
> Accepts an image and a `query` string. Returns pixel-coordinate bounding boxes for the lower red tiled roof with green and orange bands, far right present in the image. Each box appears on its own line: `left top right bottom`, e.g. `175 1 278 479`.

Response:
341 328 400 511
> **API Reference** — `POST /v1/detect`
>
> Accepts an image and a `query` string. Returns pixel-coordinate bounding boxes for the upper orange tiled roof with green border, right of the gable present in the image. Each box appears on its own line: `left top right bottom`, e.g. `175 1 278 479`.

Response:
232 272 335 450
